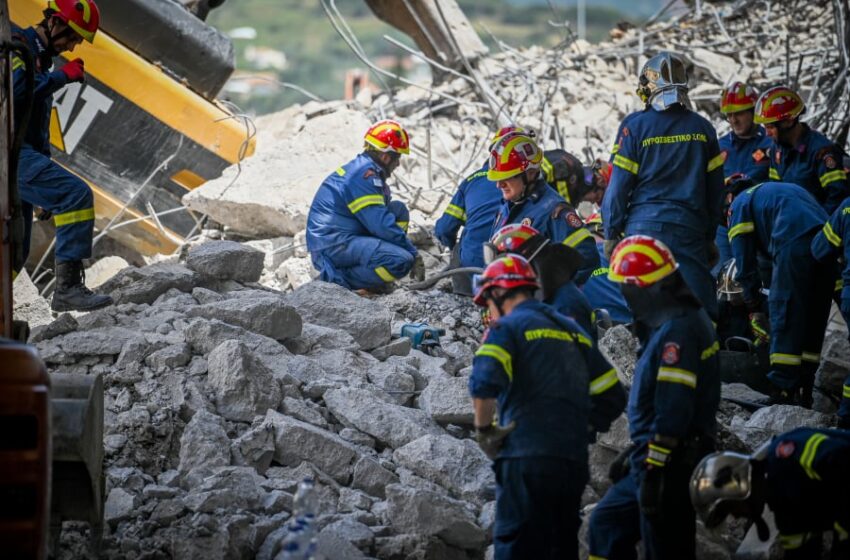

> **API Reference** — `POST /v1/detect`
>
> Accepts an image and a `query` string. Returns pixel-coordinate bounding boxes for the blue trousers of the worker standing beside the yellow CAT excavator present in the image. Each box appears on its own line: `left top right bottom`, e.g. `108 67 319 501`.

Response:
18 146 94 262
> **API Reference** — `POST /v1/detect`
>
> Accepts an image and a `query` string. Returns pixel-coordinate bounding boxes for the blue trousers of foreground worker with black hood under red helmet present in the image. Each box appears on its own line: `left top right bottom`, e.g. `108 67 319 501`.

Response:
588 462 696 560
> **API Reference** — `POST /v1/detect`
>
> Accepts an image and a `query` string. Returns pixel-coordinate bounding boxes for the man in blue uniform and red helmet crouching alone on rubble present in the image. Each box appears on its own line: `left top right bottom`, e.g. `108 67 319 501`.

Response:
307 120 424 293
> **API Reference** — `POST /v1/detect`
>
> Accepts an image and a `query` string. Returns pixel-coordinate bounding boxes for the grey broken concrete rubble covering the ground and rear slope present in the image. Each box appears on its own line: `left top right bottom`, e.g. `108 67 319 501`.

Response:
34 1 850 560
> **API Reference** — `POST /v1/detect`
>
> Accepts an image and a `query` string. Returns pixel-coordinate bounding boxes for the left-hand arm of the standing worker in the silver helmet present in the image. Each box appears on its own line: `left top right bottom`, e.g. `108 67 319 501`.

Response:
602 122 640 239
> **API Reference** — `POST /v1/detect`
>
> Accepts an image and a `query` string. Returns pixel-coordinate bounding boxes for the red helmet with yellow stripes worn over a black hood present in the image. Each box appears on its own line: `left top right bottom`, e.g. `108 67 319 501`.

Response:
608 235 679 288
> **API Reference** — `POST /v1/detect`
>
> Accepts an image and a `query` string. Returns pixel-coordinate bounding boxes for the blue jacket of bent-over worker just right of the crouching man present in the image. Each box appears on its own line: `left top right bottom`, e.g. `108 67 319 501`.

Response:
434 163 502 267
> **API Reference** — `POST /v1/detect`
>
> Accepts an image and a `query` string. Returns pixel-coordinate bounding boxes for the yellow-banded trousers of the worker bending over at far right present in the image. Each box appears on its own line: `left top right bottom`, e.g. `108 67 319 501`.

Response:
768 238 835 389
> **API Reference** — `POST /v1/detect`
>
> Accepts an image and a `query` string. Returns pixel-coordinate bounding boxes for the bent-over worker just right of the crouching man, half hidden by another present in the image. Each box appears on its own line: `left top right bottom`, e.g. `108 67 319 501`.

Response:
434 125 534 296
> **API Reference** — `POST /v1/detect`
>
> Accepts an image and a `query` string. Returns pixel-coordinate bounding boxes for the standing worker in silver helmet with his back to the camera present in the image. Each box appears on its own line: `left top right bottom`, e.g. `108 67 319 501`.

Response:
602 52 723 318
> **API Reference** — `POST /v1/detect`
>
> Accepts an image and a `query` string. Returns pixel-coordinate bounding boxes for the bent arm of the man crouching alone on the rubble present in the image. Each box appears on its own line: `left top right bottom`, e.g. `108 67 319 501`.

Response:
345 174 417 255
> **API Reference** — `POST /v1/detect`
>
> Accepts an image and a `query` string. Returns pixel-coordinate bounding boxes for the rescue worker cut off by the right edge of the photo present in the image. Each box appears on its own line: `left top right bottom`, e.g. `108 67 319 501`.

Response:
812 198 850 429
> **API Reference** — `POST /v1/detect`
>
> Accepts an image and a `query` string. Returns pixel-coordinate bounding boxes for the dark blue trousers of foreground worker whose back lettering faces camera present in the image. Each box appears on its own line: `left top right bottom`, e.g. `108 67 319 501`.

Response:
493 457 588 560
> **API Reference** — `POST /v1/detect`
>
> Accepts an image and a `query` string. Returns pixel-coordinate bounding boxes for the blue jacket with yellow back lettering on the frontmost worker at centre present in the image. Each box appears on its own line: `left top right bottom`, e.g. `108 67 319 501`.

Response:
469 300 616 462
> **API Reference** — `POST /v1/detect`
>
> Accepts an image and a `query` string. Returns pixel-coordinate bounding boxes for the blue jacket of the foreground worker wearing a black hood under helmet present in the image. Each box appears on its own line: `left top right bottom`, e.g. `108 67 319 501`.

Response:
628 308 720 445
